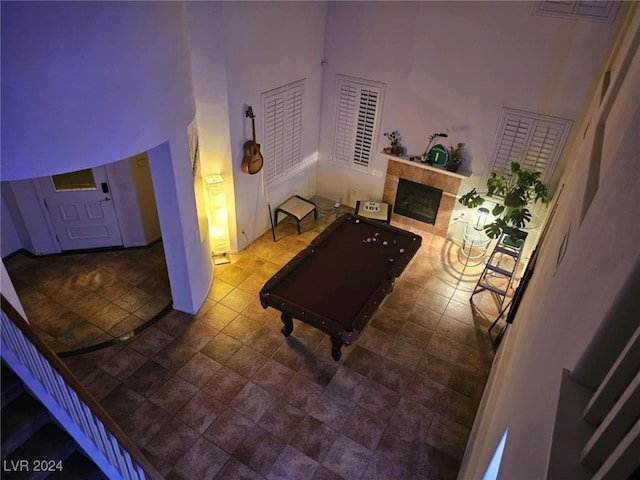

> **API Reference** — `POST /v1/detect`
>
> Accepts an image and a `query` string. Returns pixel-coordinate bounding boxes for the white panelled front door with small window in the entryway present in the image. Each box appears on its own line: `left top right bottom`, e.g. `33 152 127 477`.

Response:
38 167 122 250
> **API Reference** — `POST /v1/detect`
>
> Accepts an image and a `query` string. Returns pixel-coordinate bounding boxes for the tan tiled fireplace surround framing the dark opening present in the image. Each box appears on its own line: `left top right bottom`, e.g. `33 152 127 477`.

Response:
382 158 462 238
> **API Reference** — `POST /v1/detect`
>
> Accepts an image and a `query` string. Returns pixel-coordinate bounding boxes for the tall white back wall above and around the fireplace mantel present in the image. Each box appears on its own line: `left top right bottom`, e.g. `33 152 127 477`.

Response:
318 1 615 210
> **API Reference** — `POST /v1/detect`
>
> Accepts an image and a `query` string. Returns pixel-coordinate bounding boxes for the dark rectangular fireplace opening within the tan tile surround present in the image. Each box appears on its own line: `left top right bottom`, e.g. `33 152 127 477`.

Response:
393 178 442 225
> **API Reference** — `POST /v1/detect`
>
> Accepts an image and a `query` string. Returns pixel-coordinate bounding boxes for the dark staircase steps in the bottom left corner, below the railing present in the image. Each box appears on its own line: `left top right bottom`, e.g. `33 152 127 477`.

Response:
0 362 107 480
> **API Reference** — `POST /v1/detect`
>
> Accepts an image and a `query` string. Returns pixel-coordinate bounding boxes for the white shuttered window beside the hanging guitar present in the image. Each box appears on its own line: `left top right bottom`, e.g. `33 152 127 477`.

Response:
261 79 304 183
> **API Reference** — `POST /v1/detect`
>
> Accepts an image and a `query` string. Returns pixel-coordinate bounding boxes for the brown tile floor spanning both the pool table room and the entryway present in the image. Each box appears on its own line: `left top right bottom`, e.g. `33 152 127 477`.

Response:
5 210 508 480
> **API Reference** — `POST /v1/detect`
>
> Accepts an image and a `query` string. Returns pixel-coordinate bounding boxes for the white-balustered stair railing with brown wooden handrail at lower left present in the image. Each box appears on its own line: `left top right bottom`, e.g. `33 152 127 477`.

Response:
0 295 162 480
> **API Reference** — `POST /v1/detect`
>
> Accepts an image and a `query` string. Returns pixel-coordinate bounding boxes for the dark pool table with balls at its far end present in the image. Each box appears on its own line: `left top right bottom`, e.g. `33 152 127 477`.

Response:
260 214 422 361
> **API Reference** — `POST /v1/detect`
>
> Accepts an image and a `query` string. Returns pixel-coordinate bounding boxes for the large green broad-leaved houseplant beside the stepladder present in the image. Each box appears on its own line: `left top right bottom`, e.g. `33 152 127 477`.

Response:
458 162 548 238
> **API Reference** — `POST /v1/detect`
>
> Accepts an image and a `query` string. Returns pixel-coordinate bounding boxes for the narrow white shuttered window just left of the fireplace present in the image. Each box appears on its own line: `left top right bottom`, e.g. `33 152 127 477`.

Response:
333 75 384 169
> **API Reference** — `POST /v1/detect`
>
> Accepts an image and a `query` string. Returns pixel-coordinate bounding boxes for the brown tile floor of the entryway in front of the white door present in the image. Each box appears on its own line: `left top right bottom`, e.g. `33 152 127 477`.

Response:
3 242 171 353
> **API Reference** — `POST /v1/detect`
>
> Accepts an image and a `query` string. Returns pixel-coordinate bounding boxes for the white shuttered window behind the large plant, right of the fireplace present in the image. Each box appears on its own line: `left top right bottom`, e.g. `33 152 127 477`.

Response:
491 109 572 181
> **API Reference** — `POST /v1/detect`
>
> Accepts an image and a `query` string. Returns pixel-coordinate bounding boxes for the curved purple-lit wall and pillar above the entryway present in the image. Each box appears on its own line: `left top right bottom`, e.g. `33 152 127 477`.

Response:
1 2 212 313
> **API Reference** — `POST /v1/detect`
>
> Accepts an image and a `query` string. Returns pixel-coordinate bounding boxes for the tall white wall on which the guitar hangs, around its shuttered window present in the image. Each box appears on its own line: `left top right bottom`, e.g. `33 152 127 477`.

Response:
205 2 326 250
